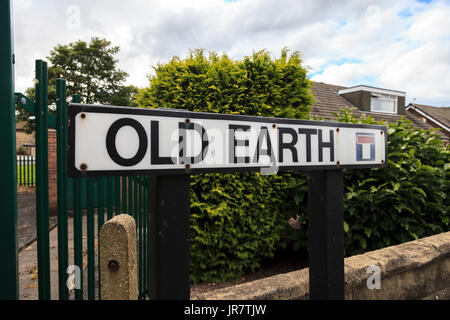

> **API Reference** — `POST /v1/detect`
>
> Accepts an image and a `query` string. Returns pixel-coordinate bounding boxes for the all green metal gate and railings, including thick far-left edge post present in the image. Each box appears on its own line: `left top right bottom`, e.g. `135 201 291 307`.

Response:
0 0 149 300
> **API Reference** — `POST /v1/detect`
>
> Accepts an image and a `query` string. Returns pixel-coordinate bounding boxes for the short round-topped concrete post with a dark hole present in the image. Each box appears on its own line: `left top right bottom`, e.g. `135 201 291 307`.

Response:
99 214 138 300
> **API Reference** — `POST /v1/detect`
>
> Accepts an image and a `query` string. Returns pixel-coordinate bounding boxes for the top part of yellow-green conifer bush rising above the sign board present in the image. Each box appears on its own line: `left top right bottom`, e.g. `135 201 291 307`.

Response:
136 50 312 118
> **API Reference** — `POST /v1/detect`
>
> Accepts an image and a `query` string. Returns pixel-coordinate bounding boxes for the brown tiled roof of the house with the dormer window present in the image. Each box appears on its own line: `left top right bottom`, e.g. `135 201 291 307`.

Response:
311 82 450 142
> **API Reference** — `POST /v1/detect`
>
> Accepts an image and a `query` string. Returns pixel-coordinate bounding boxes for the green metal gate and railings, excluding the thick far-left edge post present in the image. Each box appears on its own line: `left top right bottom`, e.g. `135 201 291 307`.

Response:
16 60 149 300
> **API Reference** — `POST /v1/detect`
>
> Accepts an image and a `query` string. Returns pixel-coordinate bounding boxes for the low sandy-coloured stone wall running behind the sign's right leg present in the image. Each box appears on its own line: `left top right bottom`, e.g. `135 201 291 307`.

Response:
198 232 450 300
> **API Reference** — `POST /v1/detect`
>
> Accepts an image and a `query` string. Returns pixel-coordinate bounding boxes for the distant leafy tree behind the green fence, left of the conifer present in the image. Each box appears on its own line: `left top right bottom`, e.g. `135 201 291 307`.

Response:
16 37 138 132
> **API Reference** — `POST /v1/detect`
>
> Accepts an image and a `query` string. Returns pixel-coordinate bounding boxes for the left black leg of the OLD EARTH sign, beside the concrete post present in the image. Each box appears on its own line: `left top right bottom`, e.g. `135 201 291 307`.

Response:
148 174 190 300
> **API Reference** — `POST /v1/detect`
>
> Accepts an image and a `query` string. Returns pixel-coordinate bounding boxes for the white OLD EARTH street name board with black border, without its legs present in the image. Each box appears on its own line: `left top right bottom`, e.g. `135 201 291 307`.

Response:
68 104 387 177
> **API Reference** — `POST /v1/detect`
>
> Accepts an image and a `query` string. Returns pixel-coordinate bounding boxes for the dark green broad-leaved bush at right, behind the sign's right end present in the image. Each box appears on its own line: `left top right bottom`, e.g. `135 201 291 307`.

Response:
288 111 450 255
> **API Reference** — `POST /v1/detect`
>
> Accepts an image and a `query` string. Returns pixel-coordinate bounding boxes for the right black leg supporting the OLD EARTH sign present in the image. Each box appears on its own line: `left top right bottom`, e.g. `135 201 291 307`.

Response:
308 170 344 300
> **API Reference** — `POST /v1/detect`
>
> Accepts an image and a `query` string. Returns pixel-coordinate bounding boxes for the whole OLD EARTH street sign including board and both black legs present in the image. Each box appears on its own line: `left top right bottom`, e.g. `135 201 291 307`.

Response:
68 104 387 300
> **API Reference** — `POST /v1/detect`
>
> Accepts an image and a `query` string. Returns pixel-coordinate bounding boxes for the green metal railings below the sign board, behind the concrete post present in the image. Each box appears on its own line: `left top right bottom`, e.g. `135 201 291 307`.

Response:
66 177 149 300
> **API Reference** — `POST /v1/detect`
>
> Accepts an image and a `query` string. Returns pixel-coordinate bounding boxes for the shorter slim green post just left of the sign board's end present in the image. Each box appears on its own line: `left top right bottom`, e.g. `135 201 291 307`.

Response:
56 79 69 300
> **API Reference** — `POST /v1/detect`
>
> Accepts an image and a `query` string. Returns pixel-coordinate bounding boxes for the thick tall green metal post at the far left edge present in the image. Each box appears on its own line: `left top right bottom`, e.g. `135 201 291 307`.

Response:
0 0 19 300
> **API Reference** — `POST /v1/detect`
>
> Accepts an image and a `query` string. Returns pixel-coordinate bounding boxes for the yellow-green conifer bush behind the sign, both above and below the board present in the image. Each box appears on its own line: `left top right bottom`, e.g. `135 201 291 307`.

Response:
136 50 312 282
